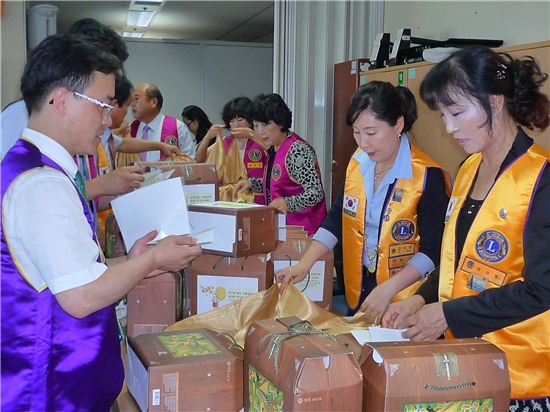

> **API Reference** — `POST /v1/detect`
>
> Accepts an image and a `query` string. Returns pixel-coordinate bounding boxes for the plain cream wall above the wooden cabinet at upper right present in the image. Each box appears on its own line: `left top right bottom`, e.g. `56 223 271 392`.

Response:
384 0 550 46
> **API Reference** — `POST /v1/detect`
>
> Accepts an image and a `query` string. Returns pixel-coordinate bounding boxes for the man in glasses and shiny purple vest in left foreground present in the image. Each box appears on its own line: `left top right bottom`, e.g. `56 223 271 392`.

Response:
0 34 201 412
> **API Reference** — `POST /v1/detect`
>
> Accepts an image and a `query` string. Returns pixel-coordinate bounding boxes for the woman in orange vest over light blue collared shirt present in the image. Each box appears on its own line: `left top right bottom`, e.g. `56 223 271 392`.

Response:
276 82 449 323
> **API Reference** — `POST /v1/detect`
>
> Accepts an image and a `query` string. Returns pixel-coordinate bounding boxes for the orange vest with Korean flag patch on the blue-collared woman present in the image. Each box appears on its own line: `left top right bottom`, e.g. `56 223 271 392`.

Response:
342 144 450 308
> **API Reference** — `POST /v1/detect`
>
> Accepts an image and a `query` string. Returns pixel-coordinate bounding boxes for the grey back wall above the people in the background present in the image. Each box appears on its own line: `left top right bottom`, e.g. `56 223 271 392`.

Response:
125 40 273 123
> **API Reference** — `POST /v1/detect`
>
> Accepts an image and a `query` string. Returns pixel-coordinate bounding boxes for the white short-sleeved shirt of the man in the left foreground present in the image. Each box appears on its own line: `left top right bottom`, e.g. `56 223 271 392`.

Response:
2 129 107 294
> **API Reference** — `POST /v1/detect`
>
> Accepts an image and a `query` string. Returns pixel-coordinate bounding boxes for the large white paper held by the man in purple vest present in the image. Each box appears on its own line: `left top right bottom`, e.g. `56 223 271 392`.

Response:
111 178 191 250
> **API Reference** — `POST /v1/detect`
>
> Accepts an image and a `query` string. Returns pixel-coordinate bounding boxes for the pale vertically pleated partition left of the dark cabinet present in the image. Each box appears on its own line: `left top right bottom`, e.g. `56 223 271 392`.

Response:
274 1 383 198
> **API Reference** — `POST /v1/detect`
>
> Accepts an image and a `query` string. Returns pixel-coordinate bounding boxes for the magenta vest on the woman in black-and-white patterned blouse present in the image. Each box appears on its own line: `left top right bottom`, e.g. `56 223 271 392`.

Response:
266 133 327 236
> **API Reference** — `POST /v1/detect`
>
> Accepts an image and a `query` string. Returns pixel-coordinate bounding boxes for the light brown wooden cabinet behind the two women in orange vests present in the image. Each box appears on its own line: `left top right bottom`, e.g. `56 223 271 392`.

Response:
356 41 550 177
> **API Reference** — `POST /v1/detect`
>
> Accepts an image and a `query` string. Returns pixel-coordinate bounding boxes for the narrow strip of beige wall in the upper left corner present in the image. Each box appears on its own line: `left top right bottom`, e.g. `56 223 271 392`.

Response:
0 1 27 107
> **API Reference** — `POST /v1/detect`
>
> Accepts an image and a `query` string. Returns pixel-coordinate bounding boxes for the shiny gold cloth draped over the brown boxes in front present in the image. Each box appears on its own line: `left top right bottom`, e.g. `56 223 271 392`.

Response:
166 284 372 346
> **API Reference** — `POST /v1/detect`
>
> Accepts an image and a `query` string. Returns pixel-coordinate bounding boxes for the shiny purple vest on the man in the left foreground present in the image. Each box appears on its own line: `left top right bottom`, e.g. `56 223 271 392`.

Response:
1 140 124 412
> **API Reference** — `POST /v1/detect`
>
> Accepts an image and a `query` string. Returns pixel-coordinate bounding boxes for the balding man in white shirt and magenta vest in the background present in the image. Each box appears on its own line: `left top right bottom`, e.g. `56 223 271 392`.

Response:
130 83 196 162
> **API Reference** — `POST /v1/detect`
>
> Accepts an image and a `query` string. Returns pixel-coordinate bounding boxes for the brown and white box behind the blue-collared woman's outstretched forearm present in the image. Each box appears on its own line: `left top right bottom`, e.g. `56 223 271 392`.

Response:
272 232 334 309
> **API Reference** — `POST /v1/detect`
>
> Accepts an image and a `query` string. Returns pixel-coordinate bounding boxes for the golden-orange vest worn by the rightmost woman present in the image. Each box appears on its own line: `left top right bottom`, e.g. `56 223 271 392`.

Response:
439 146 550 398
